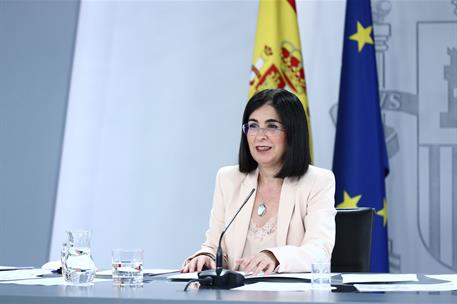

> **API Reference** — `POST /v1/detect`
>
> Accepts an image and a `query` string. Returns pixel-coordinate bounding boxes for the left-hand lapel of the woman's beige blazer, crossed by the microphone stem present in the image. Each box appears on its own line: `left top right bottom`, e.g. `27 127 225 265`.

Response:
229 169 259 260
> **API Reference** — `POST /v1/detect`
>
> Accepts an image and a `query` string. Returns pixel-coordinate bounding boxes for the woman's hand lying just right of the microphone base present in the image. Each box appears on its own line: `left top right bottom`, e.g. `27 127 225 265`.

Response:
236 250 279 275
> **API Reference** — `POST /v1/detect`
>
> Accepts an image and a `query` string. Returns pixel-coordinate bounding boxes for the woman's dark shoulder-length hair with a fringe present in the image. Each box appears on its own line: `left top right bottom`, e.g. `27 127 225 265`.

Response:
238 89 311 178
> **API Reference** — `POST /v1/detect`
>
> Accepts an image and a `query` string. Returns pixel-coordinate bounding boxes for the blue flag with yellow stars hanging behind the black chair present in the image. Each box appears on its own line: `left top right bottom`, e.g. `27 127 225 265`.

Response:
333 0 389 272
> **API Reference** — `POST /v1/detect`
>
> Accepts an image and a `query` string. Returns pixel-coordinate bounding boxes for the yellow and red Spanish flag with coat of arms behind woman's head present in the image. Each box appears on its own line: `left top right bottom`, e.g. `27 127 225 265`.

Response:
249 0 313 158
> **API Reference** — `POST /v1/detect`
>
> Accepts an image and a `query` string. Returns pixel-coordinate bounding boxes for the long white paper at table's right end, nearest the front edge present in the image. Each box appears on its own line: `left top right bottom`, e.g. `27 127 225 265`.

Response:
354 282 457 292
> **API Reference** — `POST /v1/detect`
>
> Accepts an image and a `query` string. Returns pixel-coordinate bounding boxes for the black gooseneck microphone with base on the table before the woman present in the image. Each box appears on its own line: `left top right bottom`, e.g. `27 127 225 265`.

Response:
198 188 255 289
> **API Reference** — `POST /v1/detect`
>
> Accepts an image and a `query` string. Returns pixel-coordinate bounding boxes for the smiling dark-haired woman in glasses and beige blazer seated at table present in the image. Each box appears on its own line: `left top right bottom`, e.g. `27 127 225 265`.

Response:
181 89 336 274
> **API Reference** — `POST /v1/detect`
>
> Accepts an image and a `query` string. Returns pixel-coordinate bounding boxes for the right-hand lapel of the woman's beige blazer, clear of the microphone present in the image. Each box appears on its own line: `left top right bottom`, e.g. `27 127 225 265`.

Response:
276 178 296 246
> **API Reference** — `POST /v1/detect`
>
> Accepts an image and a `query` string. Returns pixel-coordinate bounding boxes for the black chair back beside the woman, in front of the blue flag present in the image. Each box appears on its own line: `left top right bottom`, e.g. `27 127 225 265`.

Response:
331 207 374 272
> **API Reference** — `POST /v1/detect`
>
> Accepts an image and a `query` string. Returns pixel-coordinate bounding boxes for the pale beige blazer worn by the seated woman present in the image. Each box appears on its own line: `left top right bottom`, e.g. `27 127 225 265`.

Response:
188 166 336 272
